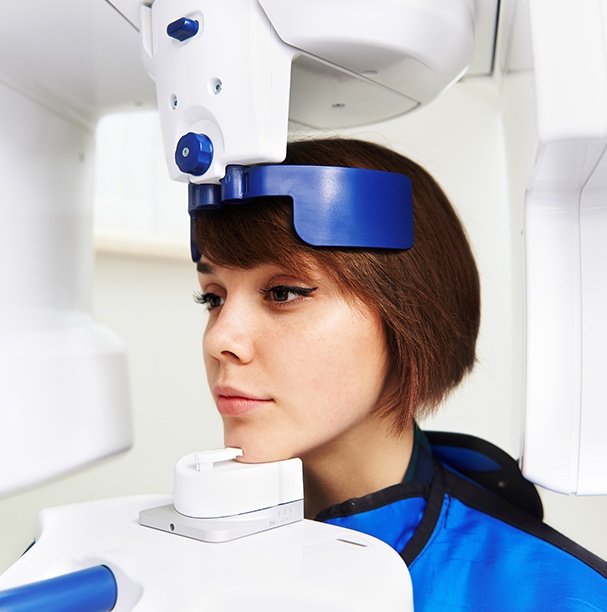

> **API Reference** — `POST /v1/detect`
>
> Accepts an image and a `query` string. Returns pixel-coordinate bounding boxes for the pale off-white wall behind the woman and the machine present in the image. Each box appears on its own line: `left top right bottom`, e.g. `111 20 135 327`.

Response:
0 75 607 571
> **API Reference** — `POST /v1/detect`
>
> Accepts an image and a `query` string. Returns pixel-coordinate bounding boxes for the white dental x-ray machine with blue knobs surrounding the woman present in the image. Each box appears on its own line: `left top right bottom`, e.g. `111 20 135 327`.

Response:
0 0 607 610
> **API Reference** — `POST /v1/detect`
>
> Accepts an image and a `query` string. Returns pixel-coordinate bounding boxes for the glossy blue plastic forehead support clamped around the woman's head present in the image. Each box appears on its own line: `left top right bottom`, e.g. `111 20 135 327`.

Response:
188 164 413 261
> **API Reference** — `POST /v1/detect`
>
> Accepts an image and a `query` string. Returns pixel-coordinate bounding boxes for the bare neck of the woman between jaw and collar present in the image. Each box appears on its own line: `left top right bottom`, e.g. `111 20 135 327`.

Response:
302 415 413 518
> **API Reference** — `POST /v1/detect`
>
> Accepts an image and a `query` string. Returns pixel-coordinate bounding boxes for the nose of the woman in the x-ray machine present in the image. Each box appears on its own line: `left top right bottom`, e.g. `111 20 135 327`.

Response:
203 298 254 363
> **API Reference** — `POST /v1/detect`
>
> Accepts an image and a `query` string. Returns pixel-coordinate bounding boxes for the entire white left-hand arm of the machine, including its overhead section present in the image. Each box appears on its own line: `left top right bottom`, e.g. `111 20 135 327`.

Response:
0 0 159 496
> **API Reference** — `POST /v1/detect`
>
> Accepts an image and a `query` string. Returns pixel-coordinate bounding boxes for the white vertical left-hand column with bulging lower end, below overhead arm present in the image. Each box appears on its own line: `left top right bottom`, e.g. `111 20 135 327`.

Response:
0 84 132 495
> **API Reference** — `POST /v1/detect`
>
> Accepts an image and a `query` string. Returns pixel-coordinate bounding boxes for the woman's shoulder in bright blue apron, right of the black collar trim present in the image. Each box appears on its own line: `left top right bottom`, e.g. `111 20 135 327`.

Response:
414 433 607 610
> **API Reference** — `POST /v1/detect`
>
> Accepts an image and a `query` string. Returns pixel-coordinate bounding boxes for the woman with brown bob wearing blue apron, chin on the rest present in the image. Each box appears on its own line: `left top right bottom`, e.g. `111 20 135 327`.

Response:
195 139 607 610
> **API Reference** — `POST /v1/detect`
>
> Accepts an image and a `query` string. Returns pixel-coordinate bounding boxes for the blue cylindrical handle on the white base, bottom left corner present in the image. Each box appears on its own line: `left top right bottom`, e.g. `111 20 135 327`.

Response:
0 565 118 612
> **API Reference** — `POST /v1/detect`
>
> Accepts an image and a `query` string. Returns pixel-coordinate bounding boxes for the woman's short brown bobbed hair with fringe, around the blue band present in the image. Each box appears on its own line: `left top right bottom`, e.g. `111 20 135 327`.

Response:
195 138 480 431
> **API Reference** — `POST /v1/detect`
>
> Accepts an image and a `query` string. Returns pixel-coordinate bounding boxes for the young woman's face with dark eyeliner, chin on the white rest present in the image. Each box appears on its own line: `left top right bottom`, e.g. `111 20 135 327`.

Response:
198 260 387 462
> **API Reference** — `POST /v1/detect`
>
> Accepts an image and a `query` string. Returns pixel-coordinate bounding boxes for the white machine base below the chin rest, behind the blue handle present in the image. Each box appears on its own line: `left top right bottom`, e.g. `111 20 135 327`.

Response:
0 496 413 612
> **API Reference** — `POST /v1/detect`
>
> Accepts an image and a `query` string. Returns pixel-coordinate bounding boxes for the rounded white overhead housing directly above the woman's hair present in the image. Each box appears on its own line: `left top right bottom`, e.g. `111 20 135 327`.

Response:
259 0 476 112
